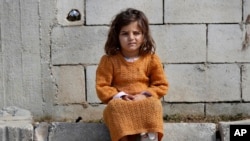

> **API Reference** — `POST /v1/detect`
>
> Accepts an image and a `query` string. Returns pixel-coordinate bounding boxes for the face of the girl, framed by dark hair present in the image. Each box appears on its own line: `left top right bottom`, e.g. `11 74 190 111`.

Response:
119 21 144 57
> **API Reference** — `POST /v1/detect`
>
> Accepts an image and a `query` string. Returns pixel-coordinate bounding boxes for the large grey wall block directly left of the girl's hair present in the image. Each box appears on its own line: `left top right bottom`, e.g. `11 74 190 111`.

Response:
51 26 108 65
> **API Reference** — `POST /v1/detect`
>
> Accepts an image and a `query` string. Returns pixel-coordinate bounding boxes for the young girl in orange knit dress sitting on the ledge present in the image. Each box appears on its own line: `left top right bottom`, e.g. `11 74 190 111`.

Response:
96 8 168 141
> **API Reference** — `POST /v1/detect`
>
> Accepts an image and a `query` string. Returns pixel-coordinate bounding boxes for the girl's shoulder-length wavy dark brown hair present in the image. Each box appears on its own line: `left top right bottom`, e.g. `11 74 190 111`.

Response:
104 8 155 55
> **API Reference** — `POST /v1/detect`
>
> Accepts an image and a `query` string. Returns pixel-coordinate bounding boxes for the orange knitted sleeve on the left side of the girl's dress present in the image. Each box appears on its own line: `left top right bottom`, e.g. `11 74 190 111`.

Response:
96 55 118 103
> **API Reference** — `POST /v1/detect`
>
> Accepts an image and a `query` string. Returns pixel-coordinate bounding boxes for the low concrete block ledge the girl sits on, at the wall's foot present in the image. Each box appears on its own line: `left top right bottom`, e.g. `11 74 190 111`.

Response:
0 120 250 141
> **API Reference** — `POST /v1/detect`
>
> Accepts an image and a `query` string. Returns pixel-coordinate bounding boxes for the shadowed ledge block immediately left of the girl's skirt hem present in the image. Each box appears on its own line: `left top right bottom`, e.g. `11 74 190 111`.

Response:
49 122 111 141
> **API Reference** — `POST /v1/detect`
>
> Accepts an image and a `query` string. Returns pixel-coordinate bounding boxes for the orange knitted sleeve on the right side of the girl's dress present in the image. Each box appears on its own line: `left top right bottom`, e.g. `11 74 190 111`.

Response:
146 54 169 99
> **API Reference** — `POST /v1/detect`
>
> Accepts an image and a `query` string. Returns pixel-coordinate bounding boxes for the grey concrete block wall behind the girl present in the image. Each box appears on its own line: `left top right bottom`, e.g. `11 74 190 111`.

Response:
0 0 250 120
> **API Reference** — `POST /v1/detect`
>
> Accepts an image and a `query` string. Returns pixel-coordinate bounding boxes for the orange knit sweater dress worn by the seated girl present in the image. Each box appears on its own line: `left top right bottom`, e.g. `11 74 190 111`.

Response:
96 53 168 141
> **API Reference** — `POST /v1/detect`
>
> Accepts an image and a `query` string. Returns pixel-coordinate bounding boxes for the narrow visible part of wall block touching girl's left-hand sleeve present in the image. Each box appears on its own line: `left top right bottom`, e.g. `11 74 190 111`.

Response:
86 65 101 103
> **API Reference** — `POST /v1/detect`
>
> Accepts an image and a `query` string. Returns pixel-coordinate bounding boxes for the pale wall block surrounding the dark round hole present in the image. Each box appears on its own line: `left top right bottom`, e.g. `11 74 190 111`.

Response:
57 0 84 26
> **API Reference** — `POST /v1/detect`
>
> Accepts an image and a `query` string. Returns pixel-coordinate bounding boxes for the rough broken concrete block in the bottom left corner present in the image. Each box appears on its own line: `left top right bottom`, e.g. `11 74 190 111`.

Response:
0 106 34 141
